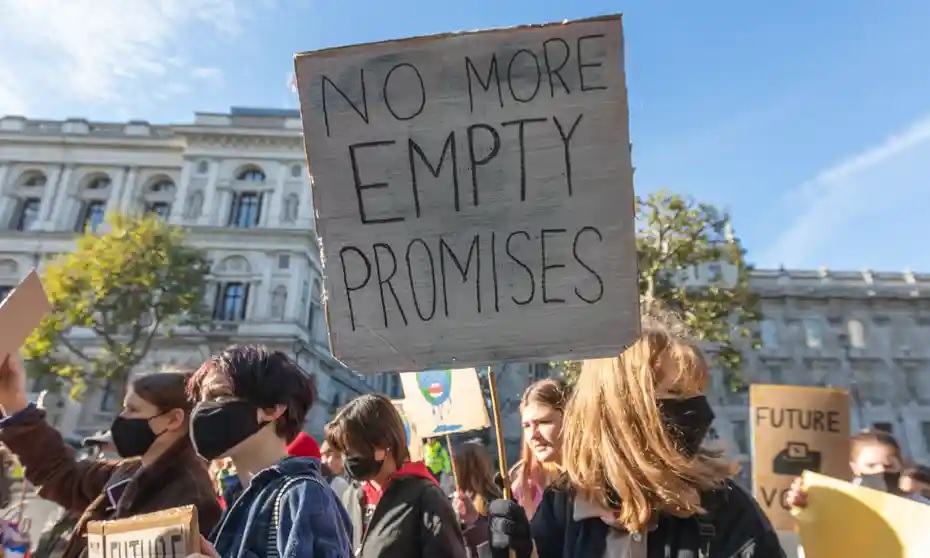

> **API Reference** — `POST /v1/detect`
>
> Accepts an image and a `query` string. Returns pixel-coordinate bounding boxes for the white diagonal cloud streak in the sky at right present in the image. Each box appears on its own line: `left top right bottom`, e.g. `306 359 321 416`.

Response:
759 116 930 268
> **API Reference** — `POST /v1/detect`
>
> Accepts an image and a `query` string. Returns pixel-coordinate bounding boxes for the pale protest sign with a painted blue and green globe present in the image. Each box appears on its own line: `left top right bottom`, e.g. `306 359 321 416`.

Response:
400 368 491 438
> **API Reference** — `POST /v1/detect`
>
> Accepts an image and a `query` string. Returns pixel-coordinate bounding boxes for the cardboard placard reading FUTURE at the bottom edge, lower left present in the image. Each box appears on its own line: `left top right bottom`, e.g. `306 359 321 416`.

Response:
87 506 200 558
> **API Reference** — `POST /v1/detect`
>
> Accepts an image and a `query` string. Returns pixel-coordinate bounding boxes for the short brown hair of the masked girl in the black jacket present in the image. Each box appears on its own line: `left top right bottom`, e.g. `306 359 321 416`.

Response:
323 393 409 466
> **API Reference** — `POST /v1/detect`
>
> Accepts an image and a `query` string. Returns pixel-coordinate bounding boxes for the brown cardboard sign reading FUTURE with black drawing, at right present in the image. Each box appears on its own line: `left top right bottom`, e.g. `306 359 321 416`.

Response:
749 385 851 529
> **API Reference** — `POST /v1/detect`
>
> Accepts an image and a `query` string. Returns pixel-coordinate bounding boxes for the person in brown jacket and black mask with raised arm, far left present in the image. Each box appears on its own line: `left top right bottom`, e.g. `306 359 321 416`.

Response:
0 356 220 558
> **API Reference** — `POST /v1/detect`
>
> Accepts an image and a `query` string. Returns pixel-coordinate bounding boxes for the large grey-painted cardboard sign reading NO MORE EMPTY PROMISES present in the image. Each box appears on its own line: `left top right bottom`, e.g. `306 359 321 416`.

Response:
295 16 639 373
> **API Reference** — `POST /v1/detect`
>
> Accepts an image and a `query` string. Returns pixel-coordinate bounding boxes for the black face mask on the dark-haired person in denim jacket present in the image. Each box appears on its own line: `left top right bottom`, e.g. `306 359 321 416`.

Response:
191 401 271 461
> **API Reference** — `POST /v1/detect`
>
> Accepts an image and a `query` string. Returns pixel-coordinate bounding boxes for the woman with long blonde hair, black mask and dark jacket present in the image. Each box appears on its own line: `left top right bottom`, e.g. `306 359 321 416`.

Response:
491 330 784 558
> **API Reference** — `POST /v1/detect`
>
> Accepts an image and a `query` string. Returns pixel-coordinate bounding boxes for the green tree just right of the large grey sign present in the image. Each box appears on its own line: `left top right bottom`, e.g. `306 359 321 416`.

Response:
557 191 761 389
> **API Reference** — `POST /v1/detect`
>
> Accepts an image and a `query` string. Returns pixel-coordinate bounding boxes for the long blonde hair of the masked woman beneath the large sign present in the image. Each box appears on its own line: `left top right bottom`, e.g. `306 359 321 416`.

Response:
562 329 732 532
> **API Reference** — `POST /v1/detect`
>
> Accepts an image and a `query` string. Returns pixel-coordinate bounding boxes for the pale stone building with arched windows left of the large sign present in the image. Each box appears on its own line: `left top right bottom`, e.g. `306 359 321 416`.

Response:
0 108 399 442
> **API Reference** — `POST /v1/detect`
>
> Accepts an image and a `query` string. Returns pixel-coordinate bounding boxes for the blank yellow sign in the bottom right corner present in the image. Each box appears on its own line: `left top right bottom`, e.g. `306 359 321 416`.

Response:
796 472 930 558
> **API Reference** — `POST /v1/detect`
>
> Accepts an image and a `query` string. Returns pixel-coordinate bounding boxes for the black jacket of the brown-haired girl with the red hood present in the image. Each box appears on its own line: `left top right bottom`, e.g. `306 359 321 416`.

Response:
342 475 468 558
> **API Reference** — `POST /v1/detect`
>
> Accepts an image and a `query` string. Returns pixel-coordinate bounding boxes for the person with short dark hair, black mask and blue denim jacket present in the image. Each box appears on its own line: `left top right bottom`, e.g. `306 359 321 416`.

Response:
188 345 351 558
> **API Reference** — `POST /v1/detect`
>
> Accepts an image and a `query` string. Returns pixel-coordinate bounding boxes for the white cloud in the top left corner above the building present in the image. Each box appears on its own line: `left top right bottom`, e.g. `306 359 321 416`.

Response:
0 0 241 115
